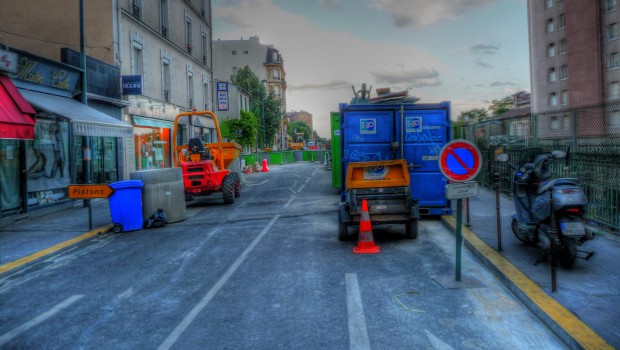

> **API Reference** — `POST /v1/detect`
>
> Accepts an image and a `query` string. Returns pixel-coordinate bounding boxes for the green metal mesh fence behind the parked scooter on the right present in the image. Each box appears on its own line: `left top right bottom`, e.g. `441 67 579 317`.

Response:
453 104 620 234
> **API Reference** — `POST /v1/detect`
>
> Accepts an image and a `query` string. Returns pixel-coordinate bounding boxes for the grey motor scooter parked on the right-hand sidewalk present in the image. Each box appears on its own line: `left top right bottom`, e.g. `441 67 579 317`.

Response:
498 148 594 267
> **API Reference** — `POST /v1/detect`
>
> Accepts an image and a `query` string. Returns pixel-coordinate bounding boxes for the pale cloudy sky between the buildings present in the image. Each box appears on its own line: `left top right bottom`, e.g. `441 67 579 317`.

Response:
212 0 530 138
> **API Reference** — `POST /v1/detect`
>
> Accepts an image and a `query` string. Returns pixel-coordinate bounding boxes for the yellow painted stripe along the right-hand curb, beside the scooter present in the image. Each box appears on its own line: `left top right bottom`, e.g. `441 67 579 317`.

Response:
442 216 613 349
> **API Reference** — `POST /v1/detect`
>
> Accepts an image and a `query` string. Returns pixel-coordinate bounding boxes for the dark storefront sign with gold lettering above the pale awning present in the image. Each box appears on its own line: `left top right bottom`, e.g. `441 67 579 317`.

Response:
10 53 80 92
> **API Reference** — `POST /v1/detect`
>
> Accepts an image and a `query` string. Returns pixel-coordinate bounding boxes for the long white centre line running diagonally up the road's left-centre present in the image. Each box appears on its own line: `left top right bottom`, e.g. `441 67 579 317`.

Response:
157 215 280 350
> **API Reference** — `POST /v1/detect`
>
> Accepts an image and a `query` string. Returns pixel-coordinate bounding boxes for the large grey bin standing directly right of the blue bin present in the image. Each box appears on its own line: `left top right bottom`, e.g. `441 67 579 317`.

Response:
129 168 185 223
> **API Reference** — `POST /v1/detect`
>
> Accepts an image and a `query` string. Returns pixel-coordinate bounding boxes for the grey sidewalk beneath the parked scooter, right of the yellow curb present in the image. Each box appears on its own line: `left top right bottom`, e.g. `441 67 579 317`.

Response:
444 187 620 349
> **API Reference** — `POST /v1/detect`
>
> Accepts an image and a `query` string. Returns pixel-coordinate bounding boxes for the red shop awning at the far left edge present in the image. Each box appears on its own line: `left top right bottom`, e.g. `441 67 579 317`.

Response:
0 75 36 140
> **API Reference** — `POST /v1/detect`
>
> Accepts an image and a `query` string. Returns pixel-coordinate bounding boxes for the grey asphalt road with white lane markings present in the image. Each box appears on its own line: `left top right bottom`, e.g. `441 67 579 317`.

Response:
0 163 564 349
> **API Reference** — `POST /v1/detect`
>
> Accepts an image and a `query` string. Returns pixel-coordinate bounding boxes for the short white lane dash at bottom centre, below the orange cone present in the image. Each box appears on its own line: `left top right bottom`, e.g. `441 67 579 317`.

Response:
345 273 370 350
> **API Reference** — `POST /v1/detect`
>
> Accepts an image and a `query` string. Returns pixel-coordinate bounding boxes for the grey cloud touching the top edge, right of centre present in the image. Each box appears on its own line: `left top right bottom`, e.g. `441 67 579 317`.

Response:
374 0 497 30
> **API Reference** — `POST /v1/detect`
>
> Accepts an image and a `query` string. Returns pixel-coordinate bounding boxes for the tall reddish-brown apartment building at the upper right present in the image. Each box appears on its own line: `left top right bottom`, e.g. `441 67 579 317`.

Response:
528 0 620 137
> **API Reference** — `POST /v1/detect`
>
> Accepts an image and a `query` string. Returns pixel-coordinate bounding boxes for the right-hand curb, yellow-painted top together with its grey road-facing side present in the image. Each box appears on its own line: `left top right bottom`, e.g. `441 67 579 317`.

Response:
441 216 613 349
